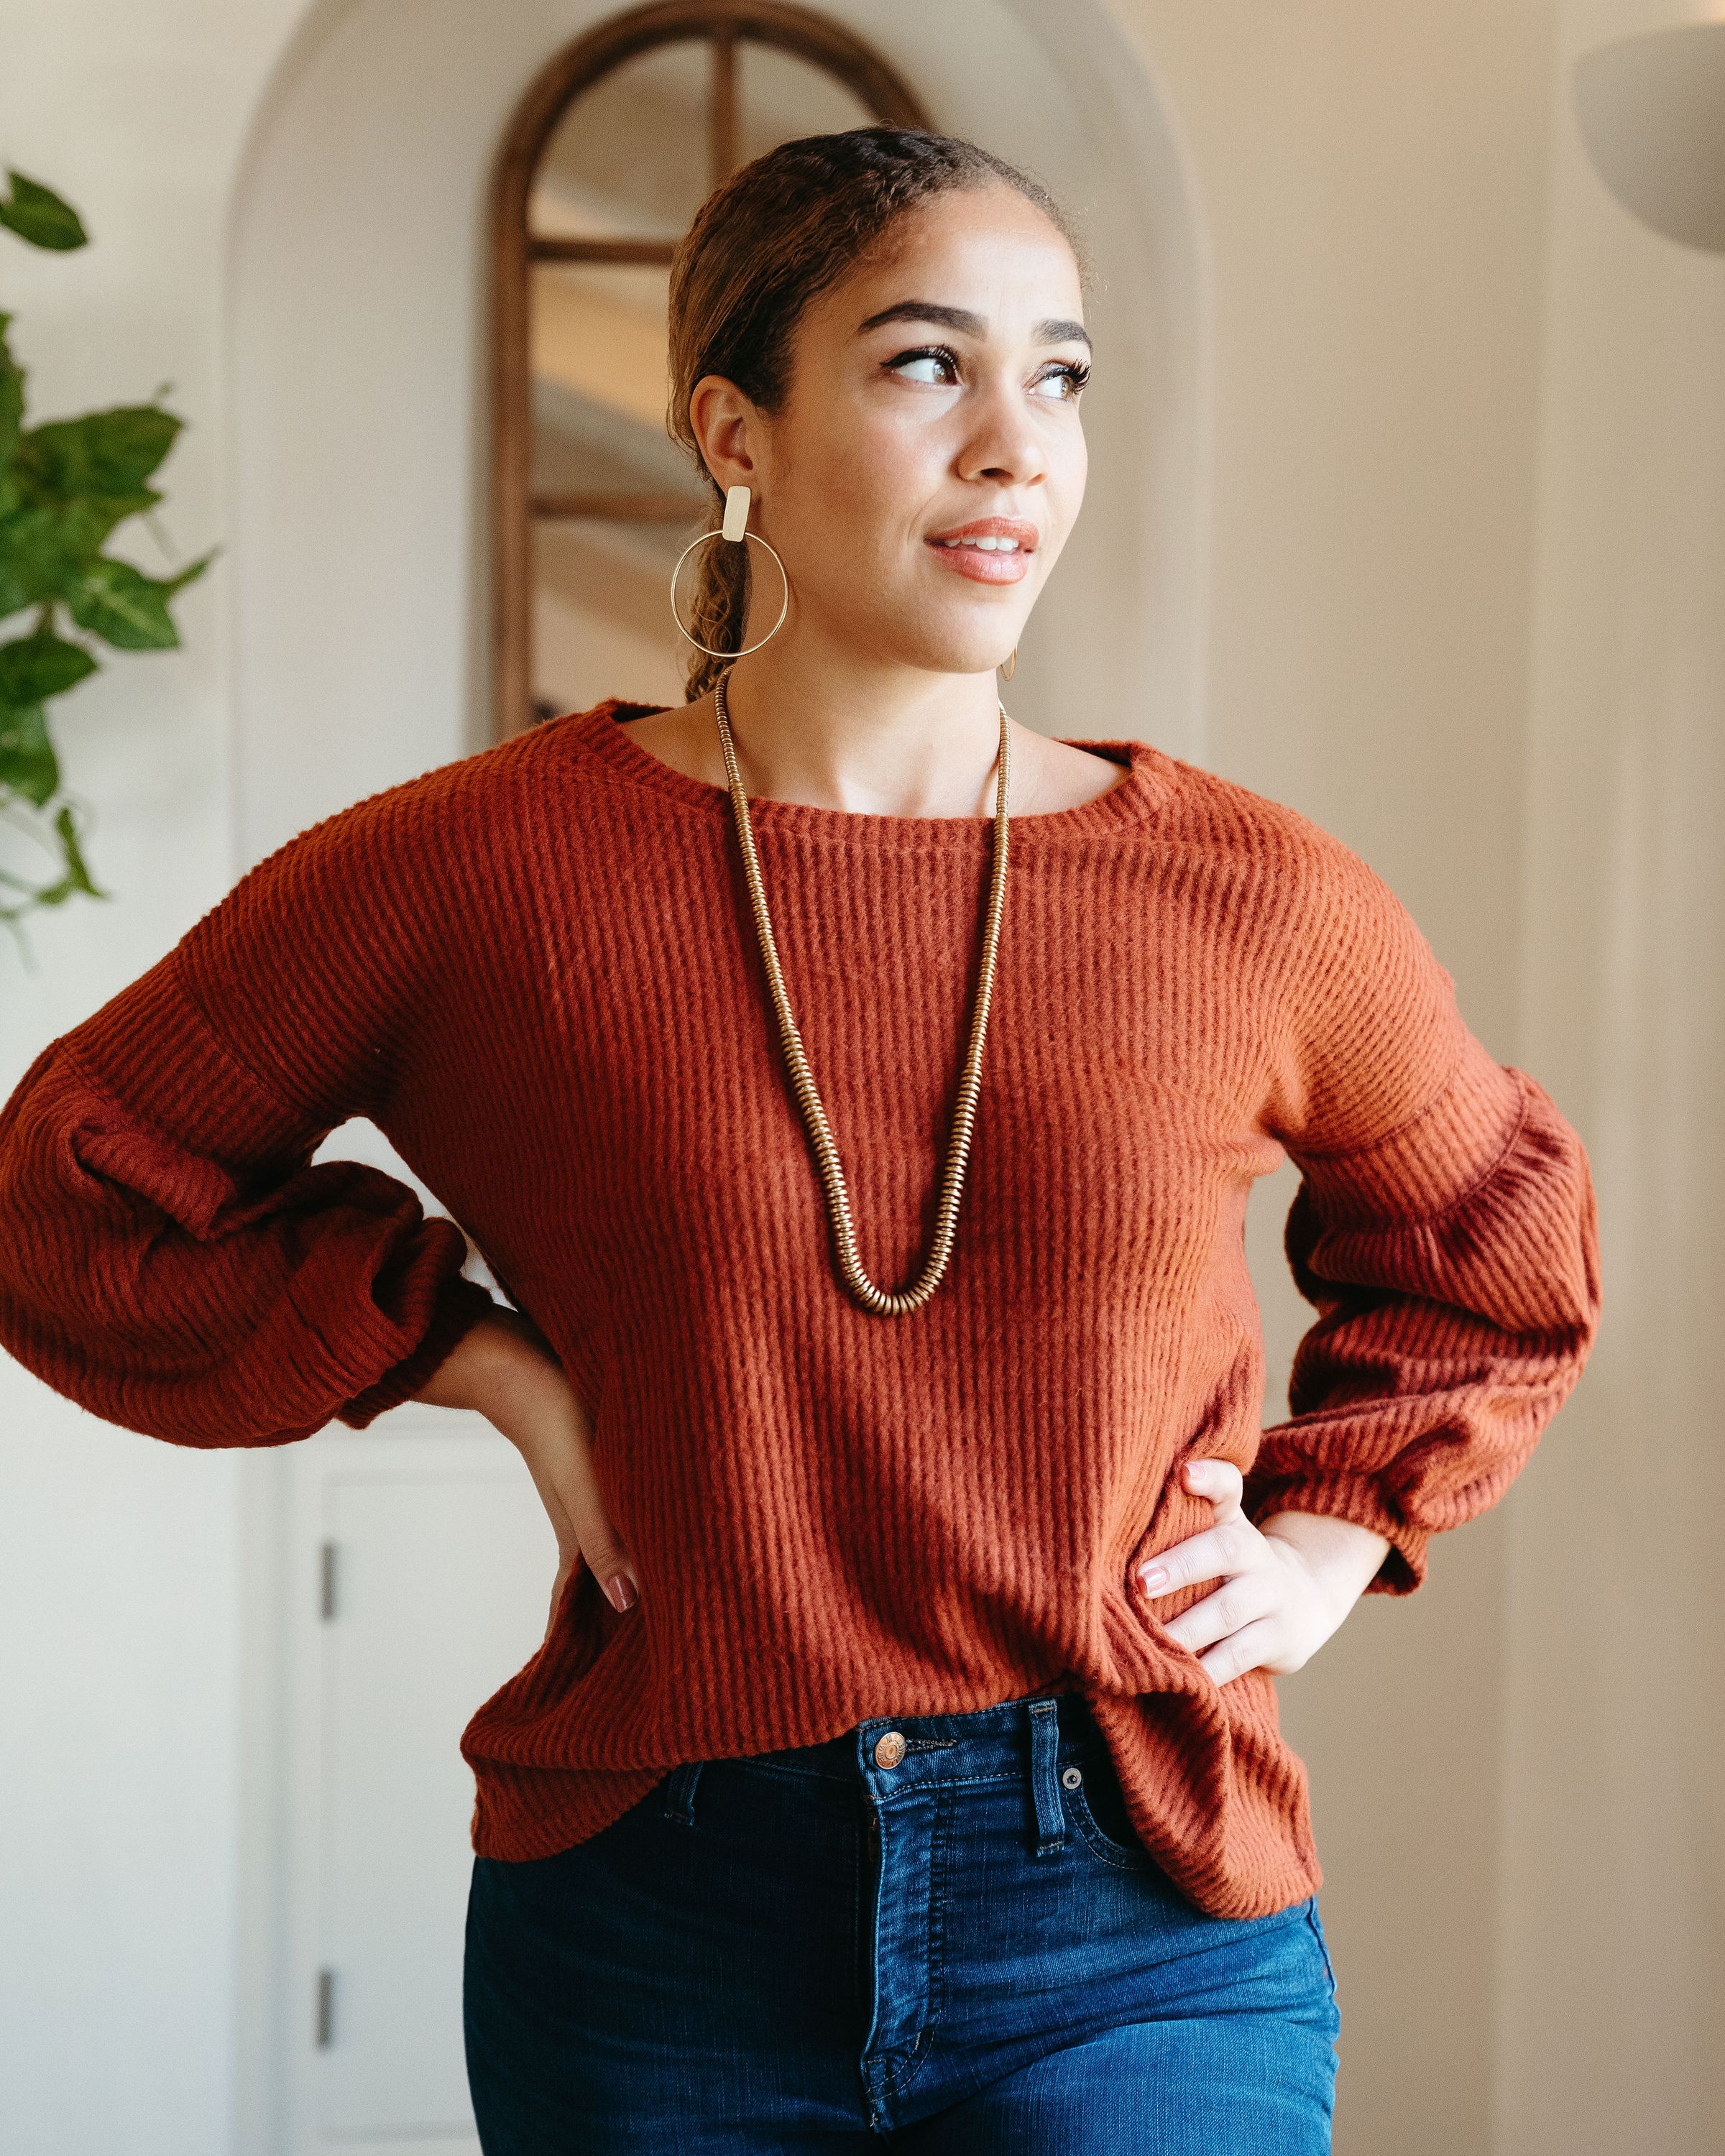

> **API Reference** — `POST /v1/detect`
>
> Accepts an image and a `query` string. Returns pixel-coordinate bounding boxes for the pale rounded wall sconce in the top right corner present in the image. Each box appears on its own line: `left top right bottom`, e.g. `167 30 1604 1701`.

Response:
1572 22 1725 254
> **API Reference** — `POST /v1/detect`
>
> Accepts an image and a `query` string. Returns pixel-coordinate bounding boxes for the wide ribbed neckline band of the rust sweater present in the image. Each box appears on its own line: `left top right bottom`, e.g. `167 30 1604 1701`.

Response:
565 696 1162 845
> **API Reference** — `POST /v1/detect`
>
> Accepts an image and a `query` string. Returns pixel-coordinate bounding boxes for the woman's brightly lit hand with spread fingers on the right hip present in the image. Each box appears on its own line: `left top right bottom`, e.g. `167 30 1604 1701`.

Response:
1138 1460 1389 1684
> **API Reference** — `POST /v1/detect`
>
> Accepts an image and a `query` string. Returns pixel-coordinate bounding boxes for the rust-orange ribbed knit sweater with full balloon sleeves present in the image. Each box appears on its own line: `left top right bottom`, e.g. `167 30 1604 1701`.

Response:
0 699 1598 1917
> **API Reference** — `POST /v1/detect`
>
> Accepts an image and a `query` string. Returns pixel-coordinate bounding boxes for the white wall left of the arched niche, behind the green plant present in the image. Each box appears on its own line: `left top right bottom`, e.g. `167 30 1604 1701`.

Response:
0 0 313 2156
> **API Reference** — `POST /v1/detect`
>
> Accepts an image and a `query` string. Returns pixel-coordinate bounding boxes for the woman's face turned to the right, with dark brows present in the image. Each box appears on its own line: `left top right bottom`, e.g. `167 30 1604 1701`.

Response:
694 185 1089 673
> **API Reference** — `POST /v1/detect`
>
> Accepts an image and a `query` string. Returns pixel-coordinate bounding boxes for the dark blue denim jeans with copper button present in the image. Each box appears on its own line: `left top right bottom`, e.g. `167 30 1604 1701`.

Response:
464 1692 1339 2156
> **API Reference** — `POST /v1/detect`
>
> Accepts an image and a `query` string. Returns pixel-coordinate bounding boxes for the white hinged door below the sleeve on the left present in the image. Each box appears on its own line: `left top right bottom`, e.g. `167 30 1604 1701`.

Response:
278 1404 556 2156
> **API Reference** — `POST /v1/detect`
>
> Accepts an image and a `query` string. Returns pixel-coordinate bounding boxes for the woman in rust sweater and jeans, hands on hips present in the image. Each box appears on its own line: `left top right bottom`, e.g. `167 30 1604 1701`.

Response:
0 127 1598 2156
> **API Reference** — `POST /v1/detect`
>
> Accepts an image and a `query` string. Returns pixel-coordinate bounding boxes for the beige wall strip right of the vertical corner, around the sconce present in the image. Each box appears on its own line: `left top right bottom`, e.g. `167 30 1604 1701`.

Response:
1499 0 1725 2156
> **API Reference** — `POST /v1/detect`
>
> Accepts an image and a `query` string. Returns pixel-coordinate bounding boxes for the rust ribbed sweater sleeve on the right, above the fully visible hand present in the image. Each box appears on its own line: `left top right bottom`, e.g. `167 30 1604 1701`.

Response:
1244 841 1600 1593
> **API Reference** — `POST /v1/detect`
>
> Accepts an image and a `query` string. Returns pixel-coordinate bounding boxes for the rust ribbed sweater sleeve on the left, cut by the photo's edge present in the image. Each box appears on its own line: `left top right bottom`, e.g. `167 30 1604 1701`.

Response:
0 796 496 1445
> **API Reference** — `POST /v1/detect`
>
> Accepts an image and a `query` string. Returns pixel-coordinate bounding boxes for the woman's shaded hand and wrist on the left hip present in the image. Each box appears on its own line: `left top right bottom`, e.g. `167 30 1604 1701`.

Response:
414 1307 638 1639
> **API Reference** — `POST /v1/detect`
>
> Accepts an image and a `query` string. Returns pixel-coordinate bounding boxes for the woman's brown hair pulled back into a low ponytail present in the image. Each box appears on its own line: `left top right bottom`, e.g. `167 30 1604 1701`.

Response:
666 125 1089 703
